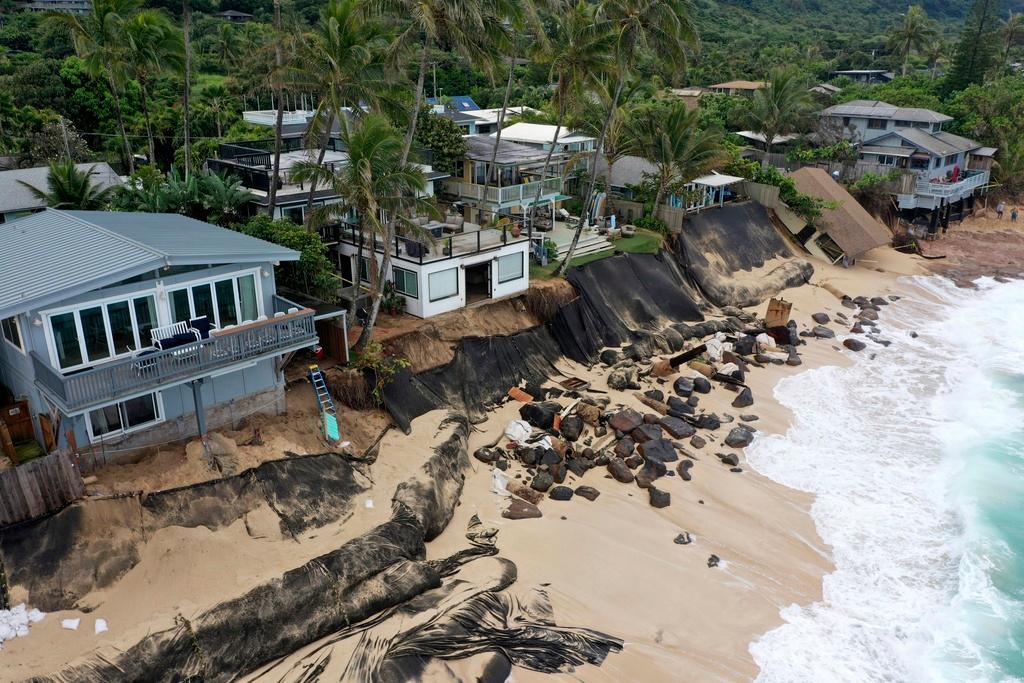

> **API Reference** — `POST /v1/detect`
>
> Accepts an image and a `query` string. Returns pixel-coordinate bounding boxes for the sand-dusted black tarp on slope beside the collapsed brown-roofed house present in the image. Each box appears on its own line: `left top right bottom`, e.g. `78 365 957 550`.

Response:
676 202 814 307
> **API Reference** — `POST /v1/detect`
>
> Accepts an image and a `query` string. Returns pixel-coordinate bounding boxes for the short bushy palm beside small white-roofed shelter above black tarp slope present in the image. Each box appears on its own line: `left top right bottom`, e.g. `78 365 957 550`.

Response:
626 102 723 223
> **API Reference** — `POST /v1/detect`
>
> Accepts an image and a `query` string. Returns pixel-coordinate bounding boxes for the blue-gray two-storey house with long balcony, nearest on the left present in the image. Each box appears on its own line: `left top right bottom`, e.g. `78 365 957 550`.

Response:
0 209 323 452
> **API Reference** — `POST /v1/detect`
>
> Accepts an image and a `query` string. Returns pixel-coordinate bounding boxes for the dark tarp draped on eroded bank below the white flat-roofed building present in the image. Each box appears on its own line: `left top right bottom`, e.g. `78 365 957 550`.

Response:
383 326 562 433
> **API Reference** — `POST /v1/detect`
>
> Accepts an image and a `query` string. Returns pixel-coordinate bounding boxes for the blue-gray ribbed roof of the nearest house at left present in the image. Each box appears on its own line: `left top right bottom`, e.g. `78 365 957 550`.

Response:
0 209 299 318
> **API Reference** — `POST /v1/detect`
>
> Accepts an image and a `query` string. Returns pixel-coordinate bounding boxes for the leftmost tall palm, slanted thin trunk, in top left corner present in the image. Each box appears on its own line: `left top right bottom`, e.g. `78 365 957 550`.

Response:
46 0 141 173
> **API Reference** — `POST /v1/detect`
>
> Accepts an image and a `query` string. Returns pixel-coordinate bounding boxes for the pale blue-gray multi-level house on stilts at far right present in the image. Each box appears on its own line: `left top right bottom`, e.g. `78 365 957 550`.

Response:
821 100 996 211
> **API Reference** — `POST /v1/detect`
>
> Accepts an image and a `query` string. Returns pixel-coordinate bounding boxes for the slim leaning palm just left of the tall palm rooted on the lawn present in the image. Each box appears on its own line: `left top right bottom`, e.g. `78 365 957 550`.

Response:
530 2 611 228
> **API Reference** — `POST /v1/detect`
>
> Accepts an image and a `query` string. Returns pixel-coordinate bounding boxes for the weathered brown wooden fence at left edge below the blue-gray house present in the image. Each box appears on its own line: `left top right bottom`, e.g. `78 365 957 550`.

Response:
0 453 85 526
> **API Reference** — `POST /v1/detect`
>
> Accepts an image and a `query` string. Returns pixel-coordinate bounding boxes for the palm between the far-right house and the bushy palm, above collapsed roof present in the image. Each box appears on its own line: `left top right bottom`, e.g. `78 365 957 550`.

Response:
740 69 814 166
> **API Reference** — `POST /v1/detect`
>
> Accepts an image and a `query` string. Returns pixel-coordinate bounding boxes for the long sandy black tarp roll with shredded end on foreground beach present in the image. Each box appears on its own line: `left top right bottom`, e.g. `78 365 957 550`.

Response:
33 418 622 683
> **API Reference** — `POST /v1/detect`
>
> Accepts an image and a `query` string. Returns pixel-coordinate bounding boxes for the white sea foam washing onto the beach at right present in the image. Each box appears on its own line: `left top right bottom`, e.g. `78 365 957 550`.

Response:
748 278 1024 683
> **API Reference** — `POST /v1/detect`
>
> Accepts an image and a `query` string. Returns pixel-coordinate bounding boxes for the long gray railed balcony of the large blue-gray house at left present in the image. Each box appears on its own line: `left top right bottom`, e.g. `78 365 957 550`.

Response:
31 297 318 415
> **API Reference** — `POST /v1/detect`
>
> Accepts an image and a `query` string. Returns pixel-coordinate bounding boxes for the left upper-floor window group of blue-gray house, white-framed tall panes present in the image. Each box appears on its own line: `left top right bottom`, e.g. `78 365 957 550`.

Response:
47 295 157 370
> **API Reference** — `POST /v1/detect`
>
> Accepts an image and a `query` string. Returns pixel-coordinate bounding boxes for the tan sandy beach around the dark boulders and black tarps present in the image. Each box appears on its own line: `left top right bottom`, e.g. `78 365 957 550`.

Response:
0 242 923 681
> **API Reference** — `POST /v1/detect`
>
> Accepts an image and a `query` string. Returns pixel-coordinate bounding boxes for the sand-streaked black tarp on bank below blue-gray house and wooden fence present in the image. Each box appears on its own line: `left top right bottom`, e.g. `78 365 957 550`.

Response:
0 454 365 611
